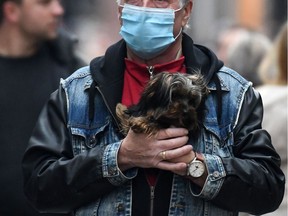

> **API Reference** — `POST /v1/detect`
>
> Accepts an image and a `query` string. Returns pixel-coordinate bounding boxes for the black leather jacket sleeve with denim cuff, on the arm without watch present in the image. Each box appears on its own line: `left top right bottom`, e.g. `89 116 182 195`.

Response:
22 88 136 213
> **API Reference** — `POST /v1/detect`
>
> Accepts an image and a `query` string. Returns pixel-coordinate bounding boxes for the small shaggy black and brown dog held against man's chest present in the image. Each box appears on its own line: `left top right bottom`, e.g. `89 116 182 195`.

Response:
116 72 209 136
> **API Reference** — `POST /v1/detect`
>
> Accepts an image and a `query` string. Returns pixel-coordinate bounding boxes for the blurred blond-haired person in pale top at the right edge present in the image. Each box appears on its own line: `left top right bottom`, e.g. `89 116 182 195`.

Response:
257 22 288 216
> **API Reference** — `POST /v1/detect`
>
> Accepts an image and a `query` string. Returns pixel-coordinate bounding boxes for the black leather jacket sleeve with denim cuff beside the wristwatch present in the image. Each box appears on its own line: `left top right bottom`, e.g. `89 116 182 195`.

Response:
192 87 285 214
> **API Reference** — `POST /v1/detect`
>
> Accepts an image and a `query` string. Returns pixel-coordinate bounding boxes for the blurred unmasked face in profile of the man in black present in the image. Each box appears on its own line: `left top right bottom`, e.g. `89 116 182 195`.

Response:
18 0 64 40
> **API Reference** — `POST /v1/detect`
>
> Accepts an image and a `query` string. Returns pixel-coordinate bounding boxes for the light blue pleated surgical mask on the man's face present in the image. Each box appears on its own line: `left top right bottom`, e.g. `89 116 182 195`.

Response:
120 4 182 60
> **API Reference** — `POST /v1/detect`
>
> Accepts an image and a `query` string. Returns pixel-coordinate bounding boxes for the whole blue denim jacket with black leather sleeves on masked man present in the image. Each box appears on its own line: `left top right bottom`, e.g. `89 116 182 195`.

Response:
22 35 285 216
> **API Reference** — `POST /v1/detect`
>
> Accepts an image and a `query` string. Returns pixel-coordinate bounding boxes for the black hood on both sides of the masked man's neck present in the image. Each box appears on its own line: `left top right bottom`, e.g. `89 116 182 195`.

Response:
90 33 223 125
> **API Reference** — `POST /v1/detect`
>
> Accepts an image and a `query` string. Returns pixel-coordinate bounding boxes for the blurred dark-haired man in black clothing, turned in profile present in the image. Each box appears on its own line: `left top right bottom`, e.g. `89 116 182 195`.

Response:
0 0 83 216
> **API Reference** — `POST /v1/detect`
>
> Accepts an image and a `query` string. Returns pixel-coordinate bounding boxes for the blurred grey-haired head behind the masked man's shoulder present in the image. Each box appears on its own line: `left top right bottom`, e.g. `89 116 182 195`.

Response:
217 25 271 87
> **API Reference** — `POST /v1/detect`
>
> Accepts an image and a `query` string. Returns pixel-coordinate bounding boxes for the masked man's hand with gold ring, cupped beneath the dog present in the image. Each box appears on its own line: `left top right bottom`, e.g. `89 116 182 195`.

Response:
118 128 192 173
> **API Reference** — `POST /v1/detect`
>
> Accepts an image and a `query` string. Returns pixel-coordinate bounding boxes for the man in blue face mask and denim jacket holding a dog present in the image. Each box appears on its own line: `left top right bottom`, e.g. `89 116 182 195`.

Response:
23 0 285 216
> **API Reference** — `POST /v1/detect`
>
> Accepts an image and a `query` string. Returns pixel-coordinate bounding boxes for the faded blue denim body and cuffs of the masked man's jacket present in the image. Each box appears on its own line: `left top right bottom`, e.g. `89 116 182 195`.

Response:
61 67 250 216
